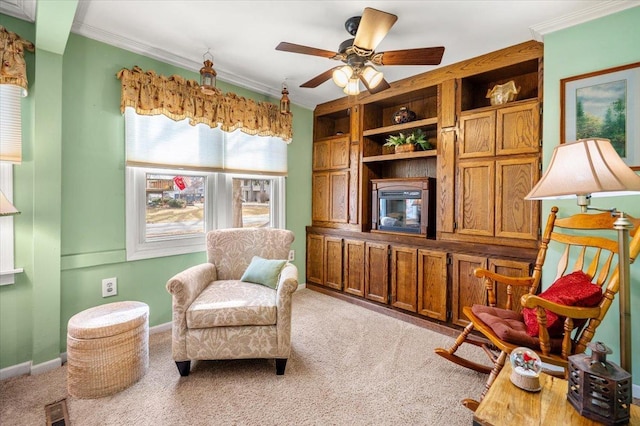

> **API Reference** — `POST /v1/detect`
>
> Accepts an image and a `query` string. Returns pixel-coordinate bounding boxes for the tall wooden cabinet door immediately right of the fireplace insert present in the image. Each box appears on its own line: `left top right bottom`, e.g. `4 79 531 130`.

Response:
456 160 495 237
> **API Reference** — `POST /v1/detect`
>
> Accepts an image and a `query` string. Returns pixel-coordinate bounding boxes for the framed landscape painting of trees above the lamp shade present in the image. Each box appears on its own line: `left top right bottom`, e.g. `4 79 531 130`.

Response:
560 62 640 170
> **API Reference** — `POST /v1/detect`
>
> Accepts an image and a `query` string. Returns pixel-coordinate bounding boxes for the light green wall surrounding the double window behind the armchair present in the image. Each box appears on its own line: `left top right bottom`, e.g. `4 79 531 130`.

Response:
0 14 313 369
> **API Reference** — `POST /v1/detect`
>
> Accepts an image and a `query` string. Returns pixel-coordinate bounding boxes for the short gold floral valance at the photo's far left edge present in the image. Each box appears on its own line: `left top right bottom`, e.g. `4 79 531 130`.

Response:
0 25 35 96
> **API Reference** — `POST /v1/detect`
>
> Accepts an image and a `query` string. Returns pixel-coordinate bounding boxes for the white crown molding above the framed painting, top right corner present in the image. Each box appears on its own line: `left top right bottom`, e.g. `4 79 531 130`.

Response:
529 0 640 41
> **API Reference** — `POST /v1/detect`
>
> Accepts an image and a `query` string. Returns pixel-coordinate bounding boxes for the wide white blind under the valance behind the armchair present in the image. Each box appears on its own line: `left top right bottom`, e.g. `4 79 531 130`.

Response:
125 107 287 176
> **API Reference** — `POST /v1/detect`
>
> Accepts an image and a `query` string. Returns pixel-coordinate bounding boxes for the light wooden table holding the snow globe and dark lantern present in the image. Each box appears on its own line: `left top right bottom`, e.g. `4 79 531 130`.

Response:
473 361 640 426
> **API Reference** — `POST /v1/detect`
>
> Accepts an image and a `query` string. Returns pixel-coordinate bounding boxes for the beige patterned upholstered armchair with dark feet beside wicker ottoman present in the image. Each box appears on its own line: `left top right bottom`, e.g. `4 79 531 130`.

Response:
167 228 298 376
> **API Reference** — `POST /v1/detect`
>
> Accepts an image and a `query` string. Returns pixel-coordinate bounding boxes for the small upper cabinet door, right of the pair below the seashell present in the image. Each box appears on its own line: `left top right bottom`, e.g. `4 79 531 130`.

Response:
496 101 540 155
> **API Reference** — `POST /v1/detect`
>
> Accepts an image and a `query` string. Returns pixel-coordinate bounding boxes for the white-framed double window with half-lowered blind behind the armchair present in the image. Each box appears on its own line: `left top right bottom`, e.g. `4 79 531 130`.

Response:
125 108 286 260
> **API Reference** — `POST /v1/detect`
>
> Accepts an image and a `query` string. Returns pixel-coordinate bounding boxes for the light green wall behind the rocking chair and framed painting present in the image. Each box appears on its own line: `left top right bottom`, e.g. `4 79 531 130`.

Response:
542 7 640 385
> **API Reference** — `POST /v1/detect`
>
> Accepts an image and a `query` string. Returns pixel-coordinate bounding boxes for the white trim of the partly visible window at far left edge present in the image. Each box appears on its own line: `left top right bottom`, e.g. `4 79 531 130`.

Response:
0 162 23 286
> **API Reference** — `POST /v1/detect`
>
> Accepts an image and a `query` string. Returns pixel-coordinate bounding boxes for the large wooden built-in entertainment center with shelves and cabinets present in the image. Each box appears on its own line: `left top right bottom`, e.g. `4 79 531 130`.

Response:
306 41 543 328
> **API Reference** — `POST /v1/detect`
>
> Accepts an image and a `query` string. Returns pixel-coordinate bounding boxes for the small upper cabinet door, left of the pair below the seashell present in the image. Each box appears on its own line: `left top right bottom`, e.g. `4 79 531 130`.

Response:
458 111 496 158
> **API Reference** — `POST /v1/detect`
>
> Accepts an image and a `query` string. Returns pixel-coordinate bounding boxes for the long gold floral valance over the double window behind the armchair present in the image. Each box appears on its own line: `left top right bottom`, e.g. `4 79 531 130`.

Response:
117 66 292 143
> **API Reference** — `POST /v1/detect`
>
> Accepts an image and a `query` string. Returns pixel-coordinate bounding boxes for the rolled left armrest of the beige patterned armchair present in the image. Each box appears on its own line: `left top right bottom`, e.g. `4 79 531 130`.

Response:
166 263 217 311
